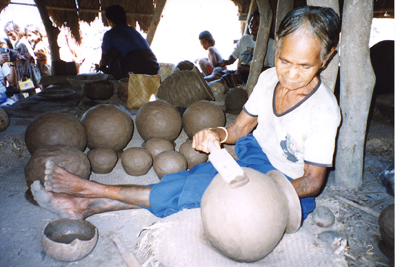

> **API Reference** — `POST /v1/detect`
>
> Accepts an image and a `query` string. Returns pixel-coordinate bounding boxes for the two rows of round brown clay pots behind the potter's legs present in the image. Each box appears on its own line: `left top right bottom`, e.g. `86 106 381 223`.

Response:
25 100 225 186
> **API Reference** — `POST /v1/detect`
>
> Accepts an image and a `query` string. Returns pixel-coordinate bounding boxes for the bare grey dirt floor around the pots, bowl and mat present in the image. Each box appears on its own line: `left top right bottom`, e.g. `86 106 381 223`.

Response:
0 82 394 266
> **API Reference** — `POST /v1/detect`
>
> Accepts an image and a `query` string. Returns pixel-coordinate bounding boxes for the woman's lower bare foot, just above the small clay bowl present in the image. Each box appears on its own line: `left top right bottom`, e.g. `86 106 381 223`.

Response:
31 181 88 219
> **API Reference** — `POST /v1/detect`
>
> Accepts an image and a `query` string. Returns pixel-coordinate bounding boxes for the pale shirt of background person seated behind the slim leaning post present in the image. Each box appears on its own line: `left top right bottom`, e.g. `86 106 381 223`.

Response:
231 34 275 67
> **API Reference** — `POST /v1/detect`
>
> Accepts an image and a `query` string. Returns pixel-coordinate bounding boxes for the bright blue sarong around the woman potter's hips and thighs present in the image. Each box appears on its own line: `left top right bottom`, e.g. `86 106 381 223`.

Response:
144 134 315 220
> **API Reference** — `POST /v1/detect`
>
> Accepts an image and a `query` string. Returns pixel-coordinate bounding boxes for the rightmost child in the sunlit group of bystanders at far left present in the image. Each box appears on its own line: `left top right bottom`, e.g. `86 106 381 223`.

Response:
25 24 51 76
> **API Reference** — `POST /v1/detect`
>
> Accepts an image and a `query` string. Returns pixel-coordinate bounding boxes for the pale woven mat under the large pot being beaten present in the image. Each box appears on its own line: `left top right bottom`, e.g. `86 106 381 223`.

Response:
137 209 348 267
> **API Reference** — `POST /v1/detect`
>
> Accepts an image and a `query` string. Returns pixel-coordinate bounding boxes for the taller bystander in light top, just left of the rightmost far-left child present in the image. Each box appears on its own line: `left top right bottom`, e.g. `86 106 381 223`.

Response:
4 21 42 89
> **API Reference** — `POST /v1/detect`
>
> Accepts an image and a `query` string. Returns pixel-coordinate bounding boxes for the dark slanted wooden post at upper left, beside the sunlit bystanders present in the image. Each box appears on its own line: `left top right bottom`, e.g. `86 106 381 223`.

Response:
35 0 60 60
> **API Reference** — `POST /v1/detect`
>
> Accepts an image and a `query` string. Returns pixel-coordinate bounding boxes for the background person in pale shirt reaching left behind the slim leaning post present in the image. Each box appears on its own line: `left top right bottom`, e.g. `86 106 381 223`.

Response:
204 10 274 88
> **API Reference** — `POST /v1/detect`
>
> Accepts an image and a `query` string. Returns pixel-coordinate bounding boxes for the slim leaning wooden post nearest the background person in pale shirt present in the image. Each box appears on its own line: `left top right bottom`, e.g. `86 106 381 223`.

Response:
246 0 272 95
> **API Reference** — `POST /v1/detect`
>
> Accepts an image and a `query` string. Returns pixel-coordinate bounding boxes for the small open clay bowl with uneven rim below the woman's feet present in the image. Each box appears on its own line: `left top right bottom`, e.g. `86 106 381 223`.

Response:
41 218 99 261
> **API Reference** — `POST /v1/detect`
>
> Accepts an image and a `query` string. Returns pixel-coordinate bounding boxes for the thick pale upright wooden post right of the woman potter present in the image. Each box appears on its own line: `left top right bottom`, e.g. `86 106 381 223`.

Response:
332 0 375 189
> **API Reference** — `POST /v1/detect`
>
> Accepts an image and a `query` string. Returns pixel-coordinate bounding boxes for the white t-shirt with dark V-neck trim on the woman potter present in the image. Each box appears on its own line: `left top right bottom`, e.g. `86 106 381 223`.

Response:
244 68 341 179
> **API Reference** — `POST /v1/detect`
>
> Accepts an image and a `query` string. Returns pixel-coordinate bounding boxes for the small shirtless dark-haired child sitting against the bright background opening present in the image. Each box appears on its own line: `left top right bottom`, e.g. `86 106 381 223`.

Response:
194 31 222 76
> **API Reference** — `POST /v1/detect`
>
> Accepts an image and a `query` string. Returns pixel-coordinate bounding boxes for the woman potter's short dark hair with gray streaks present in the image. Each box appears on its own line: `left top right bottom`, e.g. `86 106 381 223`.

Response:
275 6 340 61
